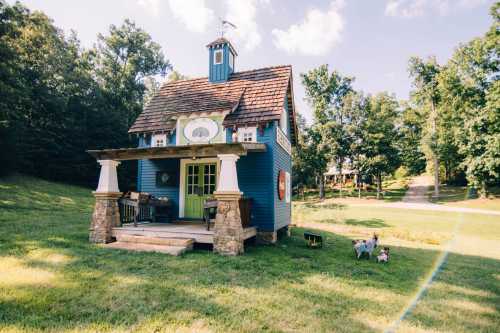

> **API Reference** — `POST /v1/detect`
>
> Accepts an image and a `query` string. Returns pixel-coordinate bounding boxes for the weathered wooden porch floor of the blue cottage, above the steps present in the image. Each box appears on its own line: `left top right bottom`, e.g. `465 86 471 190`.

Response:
112 222 257 244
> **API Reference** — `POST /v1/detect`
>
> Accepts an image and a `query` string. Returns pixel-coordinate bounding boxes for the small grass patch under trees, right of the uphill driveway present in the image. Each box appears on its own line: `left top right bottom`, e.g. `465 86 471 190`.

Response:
428 185 500 211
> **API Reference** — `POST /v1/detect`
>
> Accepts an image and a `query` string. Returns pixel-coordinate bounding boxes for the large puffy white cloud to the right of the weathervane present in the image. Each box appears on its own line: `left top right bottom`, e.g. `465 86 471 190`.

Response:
272 0 344 55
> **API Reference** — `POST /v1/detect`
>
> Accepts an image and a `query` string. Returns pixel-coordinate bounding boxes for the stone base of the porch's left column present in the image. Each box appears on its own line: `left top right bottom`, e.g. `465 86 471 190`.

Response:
89 192 122 243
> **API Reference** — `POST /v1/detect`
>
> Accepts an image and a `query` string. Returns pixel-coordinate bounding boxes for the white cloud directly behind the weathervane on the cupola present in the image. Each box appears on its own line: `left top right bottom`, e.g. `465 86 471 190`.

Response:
226 0 269 50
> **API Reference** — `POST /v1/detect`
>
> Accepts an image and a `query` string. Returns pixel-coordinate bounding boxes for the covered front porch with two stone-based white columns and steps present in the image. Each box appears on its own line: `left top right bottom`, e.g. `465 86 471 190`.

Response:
89 143 266 255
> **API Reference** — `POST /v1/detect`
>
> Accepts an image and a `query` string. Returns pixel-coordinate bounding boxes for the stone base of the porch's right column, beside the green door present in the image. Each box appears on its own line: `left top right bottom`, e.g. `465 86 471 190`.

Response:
214 191 244 256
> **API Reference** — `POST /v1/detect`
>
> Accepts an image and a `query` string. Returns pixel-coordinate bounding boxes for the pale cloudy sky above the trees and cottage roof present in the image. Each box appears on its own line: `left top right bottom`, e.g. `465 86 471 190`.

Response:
9 0 494 121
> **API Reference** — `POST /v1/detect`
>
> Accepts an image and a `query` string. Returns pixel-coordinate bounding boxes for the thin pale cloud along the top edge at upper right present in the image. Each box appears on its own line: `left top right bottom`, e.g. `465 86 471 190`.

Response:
385 0 486 18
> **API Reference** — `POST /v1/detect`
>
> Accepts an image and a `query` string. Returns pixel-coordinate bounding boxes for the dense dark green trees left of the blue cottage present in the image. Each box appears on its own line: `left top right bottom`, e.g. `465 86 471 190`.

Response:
0 0 170 183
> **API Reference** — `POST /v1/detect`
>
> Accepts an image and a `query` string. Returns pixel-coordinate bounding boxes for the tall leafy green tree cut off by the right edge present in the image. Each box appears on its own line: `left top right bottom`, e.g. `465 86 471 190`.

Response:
439 3 500 197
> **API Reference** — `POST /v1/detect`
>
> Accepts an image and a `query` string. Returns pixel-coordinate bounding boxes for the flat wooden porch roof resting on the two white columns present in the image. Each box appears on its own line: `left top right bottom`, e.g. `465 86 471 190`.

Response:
87 142 267 161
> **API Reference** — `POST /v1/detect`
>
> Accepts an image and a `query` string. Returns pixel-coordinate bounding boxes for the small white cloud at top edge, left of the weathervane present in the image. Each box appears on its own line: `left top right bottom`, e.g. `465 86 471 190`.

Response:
168 0 215 32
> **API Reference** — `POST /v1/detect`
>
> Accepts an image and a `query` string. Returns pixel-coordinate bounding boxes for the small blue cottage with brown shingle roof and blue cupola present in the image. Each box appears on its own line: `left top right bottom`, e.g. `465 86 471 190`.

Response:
87 38 297 254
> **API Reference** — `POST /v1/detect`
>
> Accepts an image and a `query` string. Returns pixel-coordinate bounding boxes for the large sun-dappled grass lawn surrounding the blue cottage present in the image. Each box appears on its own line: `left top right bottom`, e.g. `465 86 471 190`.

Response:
0 176 500 332
